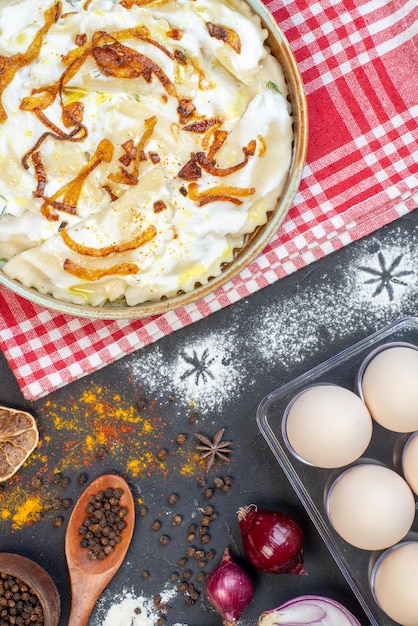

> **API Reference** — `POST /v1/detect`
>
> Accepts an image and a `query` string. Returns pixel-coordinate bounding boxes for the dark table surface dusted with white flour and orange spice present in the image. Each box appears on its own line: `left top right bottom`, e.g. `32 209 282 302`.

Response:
0 212 418 626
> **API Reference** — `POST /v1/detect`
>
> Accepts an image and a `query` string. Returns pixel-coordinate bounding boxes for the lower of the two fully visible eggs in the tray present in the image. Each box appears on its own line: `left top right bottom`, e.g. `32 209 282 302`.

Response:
327 463 415 550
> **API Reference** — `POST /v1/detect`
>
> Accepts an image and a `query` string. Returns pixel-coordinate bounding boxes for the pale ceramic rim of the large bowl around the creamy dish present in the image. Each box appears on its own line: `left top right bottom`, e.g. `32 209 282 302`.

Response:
0 0 308 319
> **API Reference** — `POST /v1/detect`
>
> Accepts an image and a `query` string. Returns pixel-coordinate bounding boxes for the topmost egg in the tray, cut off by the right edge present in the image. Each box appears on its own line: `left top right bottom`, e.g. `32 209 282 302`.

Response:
360 346 418 433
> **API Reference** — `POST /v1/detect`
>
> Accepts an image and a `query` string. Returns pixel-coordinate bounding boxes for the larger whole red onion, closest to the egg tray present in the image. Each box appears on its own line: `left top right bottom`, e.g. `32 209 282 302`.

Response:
238 504 306 574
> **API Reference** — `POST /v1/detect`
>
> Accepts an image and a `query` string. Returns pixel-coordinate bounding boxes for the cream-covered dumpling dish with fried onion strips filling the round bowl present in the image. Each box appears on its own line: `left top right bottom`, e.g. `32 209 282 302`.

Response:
0 0 293 306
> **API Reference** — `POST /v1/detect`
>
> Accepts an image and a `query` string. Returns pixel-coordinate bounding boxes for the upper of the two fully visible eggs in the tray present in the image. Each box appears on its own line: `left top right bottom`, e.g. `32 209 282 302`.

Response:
283 384 373 468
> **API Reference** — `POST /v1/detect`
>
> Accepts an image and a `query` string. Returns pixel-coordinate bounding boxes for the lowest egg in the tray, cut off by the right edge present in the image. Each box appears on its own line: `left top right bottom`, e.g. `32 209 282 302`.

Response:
372 541 418 626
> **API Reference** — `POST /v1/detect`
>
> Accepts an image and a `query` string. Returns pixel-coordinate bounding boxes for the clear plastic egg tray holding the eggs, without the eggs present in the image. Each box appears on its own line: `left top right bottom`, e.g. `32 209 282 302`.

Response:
256 317 418 626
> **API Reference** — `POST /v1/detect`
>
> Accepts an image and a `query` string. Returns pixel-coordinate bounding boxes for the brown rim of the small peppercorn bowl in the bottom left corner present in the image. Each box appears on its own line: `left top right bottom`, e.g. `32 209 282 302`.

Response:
0 552 61 626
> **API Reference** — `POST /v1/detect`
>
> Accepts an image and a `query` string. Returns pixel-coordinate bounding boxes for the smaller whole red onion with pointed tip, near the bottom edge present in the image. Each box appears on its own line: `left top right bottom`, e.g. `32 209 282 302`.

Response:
206 548 254 626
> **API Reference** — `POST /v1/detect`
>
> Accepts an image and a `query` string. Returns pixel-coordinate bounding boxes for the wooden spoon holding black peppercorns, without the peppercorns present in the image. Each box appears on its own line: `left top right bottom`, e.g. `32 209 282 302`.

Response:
65 474 135 626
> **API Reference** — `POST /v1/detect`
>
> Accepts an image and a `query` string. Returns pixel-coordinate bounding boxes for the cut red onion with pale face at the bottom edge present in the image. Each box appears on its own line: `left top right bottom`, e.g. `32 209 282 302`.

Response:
258 596 360 626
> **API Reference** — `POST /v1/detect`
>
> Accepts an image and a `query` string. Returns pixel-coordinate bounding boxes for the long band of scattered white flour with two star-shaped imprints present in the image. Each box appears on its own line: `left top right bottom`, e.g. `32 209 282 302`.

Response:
126 229 418 413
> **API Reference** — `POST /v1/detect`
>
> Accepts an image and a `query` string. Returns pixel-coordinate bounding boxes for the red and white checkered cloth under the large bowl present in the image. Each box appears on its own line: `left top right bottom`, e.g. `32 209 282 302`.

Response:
0 0 418 399
